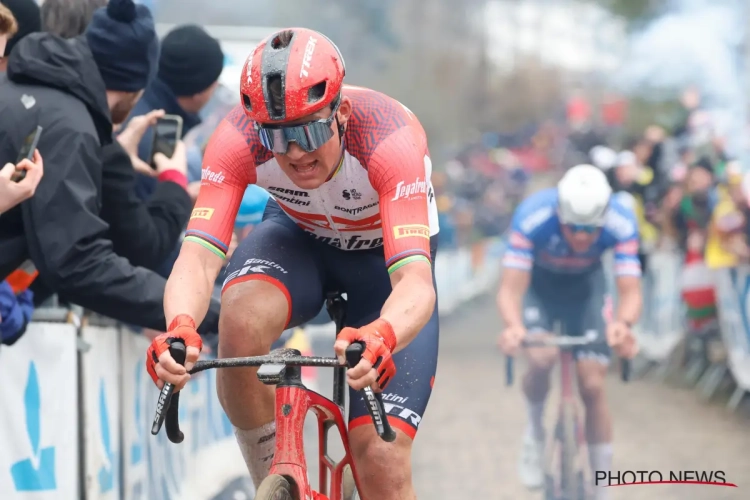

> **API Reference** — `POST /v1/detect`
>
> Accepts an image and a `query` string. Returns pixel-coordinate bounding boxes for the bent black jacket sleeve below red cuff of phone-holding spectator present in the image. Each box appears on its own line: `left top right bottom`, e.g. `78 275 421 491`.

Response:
101 141 193 270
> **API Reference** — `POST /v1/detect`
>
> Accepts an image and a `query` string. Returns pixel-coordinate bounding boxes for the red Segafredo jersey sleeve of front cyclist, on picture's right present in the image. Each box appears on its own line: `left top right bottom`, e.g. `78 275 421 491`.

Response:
368 126 431 274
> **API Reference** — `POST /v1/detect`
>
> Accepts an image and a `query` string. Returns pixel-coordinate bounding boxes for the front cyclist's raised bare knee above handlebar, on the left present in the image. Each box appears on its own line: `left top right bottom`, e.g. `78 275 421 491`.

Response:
219 280 289 358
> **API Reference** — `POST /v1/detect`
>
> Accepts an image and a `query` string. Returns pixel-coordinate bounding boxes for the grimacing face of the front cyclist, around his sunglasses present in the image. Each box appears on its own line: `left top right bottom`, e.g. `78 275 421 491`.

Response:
274 97 352 189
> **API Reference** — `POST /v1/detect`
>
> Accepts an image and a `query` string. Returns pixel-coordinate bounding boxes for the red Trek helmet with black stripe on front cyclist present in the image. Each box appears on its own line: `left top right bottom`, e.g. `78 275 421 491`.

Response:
240 28 346 124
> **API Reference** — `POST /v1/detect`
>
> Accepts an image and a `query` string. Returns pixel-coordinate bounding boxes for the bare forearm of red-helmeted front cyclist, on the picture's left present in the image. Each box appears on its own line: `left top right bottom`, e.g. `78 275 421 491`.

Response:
164 248 218 326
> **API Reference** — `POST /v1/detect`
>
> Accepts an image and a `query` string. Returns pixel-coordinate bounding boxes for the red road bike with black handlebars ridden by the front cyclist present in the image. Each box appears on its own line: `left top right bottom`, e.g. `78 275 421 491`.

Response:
151 293 396 500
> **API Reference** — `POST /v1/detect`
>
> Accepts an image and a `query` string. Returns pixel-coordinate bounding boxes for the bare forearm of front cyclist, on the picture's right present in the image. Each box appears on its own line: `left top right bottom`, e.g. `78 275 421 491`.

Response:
380 262 436 352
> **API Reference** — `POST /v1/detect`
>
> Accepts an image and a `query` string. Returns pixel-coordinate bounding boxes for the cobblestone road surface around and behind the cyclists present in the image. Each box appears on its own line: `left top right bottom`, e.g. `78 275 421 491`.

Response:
217 294 750 500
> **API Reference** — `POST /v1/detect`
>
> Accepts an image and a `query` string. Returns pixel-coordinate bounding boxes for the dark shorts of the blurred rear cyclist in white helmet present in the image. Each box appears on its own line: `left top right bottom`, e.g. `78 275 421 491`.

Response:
523 268 612 364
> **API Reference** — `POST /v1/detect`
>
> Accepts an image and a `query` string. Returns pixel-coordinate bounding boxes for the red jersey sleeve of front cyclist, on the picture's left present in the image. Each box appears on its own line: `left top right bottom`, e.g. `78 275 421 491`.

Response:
185 119 256 259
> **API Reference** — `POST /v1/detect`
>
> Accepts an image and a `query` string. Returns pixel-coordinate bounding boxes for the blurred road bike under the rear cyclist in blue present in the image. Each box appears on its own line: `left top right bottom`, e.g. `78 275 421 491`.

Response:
505 325 630 500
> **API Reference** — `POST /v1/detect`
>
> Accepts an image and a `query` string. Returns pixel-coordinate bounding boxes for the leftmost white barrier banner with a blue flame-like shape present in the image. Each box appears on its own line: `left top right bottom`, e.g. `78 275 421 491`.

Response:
0 323 79 500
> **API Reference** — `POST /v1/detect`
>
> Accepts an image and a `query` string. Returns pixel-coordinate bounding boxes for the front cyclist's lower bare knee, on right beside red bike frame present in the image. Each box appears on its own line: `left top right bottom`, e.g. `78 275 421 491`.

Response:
349 425 412 492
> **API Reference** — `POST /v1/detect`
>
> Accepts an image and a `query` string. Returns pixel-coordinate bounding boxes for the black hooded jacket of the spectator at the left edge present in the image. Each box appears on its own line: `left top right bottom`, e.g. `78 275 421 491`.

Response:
0 33 218 331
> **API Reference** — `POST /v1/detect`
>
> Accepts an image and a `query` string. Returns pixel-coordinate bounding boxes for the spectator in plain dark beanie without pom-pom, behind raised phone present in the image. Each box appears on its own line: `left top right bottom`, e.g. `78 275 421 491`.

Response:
131 25 224 199
